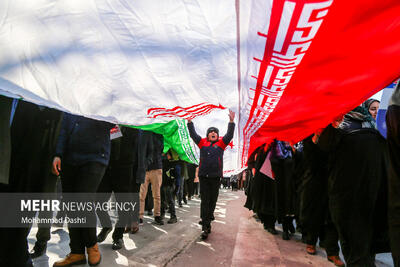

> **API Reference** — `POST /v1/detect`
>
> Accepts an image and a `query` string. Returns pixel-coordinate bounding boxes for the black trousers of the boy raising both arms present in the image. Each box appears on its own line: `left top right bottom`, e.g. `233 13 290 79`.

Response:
199 177 221 229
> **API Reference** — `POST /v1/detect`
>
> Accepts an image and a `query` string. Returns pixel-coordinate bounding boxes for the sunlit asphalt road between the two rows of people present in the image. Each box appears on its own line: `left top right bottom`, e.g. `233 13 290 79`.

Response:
28 189 393 267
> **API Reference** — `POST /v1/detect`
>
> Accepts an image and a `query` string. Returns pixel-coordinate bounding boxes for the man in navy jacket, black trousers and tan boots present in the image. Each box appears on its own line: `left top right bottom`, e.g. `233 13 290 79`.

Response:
52 113 114 267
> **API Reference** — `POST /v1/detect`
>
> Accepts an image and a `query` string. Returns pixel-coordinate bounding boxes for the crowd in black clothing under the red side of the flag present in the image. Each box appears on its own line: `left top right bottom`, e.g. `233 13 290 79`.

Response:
245 86 400 267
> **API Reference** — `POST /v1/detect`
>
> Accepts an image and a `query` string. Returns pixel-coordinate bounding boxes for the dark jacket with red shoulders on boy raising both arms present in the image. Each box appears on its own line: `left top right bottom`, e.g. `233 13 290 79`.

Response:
188 122 235 177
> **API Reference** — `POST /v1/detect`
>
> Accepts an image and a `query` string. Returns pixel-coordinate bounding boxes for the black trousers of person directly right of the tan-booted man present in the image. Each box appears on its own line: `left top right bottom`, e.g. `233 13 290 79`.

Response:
96 165 133 240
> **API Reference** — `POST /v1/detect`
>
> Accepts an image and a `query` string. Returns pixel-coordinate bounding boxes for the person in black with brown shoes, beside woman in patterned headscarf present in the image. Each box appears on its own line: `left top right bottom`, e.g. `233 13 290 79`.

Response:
300 137 344 266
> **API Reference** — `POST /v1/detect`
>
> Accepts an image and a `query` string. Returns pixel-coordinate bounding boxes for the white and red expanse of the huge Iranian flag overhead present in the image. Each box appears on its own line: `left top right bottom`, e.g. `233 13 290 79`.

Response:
0 0 400 170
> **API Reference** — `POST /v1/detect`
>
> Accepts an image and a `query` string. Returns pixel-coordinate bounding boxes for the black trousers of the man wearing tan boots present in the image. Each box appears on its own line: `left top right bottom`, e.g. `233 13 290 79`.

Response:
61 162 106 254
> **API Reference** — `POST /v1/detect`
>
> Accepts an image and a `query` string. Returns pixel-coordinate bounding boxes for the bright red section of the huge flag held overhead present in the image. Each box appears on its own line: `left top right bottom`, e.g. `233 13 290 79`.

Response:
244 0 400 164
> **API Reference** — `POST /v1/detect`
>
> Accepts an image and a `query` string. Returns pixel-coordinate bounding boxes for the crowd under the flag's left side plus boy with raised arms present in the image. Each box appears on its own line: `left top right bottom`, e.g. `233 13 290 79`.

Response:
0 96 234 266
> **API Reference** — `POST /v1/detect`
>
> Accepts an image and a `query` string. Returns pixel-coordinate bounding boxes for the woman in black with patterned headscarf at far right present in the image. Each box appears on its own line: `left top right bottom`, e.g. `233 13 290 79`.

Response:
318 107 389 267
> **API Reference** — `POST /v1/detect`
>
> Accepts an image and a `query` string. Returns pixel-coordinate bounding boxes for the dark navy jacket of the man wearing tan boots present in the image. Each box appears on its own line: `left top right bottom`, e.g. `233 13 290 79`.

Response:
56 113 114 168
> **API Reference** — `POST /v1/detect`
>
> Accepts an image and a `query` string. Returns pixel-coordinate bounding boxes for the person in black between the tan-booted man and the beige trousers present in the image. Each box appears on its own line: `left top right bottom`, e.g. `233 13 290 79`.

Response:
96 126 149 250
